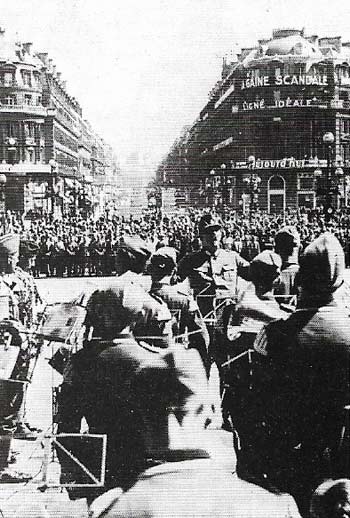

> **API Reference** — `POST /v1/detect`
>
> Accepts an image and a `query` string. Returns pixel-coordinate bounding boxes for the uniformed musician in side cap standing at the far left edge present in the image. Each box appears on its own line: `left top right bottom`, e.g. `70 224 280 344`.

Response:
0 234 42 484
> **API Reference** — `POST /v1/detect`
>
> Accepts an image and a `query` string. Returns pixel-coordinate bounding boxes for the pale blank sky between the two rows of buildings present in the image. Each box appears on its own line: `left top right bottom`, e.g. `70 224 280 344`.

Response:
0 0 350 172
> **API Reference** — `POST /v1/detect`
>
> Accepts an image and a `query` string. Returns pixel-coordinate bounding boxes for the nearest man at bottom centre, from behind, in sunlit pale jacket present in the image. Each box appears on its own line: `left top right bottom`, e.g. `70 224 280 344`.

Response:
90 349 300 518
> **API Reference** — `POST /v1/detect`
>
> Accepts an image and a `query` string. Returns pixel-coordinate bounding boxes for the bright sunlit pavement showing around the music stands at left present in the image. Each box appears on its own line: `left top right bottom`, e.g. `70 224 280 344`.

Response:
0 278 108 518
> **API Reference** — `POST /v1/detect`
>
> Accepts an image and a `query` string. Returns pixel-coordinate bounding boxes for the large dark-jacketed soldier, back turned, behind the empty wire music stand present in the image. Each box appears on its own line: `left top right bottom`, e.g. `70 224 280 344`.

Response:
58 279 174 504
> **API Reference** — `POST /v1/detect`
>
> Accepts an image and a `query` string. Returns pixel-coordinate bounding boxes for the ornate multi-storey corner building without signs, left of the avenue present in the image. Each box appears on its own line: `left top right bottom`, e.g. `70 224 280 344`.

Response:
0 29 118 216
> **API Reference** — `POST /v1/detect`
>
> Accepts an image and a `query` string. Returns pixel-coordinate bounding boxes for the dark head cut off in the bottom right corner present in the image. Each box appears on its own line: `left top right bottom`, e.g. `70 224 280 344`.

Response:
310 478 350 518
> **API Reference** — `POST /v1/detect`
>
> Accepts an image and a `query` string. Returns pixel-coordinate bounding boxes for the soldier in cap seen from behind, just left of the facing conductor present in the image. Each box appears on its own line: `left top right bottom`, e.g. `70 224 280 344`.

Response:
150 246 209 365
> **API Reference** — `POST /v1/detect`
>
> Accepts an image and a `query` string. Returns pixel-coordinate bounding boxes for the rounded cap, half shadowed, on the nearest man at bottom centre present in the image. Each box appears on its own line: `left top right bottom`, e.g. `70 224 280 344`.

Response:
133 348 209 414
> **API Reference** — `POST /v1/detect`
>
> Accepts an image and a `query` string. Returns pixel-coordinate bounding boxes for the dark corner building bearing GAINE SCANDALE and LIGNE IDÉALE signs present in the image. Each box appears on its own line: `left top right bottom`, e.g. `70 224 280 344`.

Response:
157 29 350 212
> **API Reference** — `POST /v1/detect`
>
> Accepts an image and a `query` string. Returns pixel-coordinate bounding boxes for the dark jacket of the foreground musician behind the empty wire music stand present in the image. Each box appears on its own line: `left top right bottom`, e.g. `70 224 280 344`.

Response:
58 335 160 498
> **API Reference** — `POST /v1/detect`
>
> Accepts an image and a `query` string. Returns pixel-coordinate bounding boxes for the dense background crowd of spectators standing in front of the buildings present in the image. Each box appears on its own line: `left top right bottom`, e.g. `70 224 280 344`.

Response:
2 209 350 277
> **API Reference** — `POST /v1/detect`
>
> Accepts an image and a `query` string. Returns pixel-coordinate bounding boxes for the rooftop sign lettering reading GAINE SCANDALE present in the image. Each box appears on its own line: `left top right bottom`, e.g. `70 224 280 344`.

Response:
241 74 328 90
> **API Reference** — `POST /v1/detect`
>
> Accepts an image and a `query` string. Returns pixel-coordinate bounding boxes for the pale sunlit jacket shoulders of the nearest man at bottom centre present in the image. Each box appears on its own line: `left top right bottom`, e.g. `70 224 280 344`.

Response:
92 454 300 518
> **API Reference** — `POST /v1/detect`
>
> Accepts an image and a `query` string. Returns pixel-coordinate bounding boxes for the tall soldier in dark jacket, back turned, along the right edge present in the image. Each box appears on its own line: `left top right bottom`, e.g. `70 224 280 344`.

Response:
252 232 350 511
